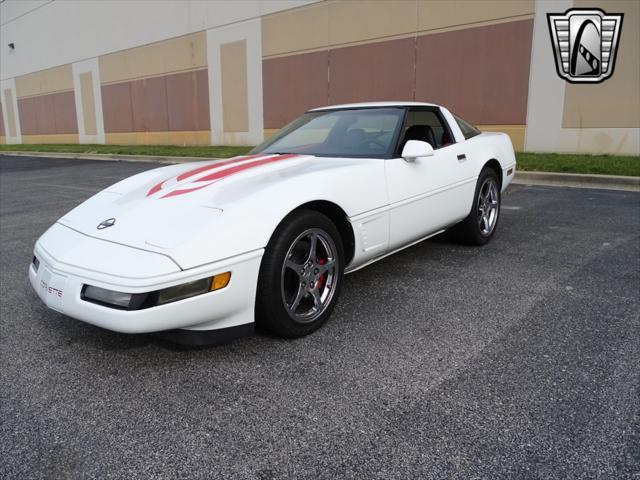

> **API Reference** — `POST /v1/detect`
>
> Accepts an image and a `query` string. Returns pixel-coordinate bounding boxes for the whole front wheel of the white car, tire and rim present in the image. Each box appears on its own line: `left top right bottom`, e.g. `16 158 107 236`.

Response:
256 210 344 338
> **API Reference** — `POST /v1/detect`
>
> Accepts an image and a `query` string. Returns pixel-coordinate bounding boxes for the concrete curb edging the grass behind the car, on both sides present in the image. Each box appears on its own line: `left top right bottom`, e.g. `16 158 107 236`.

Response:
0 151 640 192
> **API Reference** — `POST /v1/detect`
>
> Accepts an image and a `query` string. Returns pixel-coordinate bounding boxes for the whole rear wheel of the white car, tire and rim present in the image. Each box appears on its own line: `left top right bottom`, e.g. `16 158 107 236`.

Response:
454 168 502 245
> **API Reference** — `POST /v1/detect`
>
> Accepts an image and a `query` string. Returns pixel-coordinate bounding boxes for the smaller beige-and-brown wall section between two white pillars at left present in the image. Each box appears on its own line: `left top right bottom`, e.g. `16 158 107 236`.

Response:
98 32 211 145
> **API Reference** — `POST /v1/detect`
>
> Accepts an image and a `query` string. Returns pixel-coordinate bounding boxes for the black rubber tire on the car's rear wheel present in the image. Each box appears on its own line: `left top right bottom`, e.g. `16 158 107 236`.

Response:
453 167 502 245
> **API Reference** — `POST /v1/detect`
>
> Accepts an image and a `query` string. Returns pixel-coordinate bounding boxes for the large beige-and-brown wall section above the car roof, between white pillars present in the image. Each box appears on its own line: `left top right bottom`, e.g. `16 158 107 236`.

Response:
262 0 534 150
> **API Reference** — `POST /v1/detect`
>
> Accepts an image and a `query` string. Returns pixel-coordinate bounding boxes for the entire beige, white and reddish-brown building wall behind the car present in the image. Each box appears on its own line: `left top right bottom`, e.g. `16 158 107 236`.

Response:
0 0 640 155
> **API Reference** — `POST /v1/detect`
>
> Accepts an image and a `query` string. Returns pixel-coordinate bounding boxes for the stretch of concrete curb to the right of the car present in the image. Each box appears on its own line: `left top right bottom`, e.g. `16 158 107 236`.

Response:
513 171 640 192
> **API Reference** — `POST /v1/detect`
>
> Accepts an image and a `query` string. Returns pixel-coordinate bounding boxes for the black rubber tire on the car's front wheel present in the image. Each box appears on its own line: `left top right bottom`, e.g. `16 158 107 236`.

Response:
256 210 344 338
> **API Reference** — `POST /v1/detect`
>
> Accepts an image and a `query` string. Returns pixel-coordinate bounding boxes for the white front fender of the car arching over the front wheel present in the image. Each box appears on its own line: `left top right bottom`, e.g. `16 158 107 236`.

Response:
169 158 388 268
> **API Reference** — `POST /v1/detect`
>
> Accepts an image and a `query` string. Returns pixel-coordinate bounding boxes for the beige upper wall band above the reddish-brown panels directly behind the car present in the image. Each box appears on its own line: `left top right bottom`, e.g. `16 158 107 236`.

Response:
262 0 534 58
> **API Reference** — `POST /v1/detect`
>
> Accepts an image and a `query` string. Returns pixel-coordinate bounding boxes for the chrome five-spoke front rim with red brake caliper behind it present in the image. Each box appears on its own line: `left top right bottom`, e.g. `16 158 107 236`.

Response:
280 228 338 323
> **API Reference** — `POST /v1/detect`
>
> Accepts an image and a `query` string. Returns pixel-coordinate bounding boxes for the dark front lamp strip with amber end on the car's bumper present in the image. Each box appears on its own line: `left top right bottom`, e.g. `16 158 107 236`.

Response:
80 272 231 310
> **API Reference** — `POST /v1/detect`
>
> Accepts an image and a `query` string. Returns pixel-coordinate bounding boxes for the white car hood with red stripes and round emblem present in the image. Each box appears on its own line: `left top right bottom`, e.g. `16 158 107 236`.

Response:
58 154 372 268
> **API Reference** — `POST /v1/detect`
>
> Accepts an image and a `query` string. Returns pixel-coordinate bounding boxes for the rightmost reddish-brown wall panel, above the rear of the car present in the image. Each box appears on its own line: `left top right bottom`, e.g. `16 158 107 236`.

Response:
416 20 533 125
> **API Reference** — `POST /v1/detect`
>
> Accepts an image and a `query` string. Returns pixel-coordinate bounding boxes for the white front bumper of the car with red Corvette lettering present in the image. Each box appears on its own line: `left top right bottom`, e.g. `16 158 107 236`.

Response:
29 227 263 337
